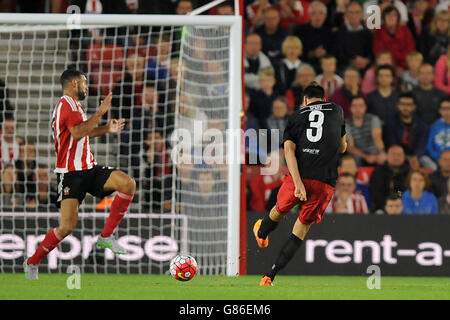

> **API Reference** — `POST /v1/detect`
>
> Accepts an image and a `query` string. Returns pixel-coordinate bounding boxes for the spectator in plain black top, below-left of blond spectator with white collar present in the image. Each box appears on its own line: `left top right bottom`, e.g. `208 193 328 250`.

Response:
249 68 280 128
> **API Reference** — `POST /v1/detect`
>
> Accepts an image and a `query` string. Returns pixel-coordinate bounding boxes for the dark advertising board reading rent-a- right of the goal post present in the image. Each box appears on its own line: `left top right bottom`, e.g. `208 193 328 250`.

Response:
247 212 450 276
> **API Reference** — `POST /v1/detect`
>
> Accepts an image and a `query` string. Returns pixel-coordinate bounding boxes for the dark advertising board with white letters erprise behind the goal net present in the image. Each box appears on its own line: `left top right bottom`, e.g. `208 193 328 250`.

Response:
0 213 187 274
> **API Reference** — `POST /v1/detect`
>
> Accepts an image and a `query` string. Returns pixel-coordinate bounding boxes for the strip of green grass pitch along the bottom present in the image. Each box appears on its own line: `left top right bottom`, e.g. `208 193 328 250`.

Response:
0 273 450 300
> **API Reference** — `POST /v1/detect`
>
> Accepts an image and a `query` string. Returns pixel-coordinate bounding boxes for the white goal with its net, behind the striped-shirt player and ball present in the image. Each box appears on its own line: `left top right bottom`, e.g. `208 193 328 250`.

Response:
0 13 242 276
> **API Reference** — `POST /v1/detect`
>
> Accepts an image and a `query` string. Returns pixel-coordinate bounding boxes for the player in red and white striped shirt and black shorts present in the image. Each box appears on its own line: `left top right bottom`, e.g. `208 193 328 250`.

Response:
24 70 136 279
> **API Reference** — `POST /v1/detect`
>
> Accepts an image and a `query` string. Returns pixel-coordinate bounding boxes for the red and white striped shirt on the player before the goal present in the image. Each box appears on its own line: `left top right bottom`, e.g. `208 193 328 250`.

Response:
52 96 97 173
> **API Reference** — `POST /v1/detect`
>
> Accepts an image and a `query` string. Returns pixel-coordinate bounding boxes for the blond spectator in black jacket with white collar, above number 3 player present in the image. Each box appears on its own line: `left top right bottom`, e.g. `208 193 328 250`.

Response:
274 36 303 94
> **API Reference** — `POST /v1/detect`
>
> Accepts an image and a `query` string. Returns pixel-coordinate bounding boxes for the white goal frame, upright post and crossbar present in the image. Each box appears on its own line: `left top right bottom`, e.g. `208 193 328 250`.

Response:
0 13 242 276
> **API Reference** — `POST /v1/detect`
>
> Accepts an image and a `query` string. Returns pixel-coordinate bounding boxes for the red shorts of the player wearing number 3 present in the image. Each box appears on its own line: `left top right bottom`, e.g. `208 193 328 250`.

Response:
276 175 334 225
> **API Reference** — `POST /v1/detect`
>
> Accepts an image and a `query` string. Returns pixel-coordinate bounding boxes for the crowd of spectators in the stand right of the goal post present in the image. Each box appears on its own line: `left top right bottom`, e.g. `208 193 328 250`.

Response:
245 0 450 214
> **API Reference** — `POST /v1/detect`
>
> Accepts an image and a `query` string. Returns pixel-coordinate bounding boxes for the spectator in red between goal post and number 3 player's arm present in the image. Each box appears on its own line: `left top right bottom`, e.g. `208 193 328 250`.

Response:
250 150 284 212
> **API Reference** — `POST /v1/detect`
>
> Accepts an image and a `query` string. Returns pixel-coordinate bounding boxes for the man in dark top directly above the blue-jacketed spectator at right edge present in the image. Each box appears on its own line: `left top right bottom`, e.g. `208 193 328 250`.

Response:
412 63 445 127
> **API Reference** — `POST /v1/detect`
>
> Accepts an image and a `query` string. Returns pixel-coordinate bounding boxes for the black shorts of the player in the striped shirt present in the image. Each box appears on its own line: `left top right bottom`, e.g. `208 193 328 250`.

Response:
57 166 117 208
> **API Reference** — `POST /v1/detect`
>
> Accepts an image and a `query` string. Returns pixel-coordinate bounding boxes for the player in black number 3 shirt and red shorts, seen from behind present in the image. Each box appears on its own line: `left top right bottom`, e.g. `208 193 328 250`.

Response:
253 83 347 286
